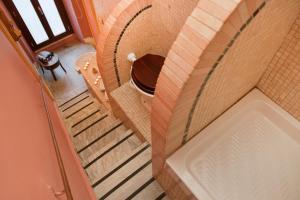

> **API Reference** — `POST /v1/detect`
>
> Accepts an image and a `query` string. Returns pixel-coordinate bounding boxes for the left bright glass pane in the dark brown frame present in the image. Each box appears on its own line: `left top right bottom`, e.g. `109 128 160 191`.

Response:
13 0 49 44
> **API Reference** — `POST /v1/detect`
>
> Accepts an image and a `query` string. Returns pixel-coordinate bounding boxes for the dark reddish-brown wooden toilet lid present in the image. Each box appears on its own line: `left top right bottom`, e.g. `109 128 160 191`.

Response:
131 54 165 94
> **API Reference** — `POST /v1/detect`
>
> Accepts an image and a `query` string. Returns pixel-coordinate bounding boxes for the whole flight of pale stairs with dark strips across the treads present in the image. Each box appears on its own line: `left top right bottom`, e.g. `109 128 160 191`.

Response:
59 91 167 200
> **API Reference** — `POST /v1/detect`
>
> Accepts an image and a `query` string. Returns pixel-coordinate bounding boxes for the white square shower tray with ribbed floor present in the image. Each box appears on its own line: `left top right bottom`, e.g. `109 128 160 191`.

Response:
167 89 300 200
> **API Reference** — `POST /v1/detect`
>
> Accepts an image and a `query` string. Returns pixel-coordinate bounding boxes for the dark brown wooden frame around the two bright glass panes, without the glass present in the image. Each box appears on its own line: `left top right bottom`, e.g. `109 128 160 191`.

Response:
3 0 73 51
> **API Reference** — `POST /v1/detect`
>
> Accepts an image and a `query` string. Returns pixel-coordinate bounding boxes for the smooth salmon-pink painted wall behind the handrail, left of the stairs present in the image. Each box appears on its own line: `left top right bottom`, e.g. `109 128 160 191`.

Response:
0 27 95 200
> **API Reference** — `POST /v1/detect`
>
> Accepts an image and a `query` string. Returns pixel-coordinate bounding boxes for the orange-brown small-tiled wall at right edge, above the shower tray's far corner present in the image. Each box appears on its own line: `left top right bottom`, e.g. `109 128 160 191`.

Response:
258 15 300 120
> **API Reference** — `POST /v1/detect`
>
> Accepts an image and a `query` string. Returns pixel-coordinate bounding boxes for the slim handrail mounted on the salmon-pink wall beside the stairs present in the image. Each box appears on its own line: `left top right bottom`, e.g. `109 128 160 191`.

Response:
40 77 73 200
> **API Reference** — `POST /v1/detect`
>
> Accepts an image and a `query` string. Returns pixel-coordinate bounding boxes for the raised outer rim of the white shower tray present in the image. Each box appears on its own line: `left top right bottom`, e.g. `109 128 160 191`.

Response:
166 88 300 200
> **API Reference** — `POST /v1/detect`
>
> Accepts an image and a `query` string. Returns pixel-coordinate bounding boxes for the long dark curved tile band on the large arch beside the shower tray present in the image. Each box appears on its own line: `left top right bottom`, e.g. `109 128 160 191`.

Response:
182 1 266 144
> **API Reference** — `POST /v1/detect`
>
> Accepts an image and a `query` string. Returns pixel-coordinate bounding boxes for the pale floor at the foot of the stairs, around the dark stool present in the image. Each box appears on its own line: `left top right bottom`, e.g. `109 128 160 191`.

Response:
40 43 95 104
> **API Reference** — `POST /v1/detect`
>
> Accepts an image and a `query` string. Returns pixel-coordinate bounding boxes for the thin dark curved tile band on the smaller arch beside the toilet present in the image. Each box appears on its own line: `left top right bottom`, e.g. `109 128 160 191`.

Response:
113 5 152 87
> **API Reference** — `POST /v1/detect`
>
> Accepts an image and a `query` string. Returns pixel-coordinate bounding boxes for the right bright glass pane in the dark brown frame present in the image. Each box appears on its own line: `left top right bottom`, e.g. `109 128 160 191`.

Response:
38 0 66 36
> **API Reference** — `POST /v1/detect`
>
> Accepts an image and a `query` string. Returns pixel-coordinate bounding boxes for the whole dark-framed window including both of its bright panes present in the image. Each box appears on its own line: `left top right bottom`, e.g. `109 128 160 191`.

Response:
4 0 73 50
